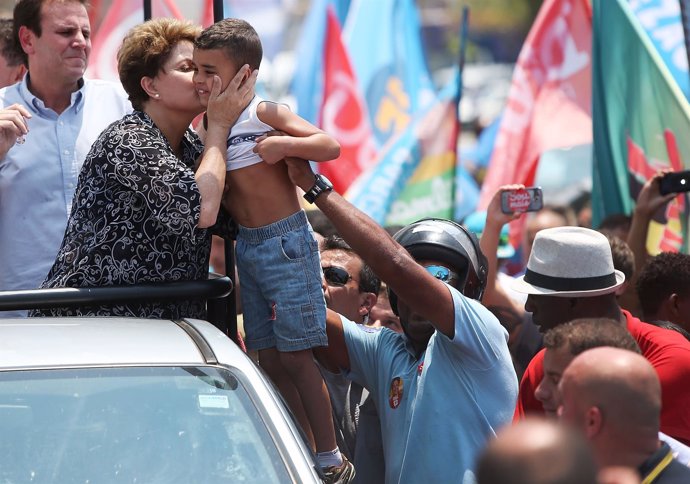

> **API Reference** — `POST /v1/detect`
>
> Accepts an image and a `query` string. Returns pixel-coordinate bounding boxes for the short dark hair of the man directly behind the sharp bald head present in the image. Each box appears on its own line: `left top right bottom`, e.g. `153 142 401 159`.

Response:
544 318 641 355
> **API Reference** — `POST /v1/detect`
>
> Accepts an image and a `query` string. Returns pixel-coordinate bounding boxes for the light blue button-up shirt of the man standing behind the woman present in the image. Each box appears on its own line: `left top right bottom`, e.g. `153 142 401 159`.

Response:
0 74 132 318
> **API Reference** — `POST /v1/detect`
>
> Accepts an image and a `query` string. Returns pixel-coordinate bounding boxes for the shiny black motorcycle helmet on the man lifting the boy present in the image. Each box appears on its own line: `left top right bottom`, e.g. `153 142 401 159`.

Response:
388 218 488 314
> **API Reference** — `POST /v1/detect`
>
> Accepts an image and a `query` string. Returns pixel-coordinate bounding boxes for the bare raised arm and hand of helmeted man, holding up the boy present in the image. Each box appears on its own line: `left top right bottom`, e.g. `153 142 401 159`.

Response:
286 158 455 338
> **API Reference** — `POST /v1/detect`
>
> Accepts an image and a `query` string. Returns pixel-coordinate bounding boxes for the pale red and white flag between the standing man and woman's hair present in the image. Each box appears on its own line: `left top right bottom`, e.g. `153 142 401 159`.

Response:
87 0 192 81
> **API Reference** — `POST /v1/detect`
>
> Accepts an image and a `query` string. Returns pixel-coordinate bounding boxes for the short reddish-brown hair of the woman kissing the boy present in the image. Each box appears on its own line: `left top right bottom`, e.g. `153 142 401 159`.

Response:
117 18 200 111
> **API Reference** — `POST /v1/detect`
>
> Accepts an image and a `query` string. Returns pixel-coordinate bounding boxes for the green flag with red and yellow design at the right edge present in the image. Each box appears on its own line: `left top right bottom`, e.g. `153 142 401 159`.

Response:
592 0 690 253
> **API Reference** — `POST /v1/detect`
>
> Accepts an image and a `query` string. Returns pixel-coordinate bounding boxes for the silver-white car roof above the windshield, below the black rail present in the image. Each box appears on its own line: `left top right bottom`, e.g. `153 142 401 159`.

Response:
0 317 248 370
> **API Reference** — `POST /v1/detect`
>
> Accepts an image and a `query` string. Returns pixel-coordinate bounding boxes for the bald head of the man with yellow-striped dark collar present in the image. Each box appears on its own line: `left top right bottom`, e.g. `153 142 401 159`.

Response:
560 347 661 454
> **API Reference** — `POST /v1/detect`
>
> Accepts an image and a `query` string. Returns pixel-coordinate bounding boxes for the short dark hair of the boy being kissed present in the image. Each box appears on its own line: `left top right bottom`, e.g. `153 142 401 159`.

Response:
194 18 263 70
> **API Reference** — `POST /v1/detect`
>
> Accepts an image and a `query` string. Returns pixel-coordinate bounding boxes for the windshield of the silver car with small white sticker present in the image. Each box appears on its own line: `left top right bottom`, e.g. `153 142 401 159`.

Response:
0 367 290 484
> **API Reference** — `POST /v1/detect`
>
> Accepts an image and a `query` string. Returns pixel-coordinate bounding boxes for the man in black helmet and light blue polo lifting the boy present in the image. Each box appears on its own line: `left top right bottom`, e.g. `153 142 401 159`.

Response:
287 159 518 482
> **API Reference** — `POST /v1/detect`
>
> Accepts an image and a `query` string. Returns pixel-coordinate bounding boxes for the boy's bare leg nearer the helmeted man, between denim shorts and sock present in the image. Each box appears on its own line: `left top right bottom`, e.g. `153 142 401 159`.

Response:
279 350 338 453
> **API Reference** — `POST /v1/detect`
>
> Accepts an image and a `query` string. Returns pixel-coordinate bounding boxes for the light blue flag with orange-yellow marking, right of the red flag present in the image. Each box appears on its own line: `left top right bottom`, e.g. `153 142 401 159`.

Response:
343 0 436 147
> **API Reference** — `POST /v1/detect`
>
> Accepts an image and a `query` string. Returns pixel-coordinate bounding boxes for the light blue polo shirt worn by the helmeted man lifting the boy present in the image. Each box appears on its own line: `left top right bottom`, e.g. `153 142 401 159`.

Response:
343 286 518 483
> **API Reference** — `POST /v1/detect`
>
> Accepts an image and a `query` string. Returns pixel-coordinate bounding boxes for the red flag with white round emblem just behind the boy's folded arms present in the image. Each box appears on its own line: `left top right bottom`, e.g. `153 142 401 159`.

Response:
319 6 376 193
